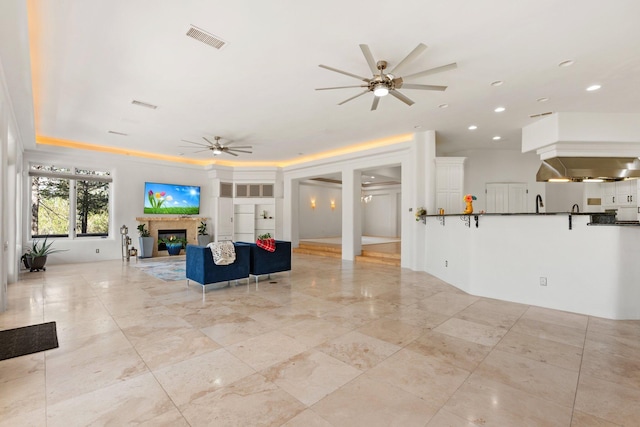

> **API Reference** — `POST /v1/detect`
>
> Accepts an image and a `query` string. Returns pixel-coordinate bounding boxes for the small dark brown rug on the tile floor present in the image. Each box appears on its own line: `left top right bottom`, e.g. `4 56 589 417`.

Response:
0 322 58 360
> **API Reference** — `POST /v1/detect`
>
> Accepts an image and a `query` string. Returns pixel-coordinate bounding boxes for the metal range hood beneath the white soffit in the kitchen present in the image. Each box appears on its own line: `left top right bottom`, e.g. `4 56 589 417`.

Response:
536 157 640 182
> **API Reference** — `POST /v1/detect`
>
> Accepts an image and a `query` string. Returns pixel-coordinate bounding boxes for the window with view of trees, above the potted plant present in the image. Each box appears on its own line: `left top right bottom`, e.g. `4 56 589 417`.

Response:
29 165 112 237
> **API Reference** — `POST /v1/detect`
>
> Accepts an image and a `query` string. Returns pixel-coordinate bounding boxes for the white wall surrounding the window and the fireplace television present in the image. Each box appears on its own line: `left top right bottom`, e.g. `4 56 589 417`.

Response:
22 148 213 264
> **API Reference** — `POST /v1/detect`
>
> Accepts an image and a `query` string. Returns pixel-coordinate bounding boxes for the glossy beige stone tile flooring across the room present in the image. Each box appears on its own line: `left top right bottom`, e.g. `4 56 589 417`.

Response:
0 254 640 427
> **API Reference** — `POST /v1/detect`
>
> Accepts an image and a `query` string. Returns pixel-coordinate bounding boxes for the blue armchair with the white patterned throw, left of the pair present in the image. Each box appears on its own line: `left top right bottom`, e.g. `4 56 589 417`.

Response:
186 243 251 294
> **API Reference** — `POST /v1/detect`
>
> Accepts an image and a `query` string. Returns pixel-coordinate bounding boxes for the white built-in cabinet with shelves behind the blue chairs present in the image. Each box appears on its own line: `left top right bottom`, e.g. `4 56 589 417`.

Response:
233 203 276 242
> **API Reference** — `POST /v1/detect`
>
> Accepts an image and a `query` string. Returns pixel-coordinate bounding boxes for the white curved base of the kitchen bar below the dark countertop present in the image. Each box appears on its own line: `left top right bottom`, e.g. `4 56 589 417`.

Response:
424 216 640 319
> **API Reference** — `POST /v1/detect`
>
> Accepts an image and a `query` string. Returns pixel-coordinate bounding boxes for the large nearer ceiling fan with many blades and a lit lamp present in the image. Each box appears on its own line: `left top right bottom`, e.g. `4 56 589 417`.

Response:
316 43 458 111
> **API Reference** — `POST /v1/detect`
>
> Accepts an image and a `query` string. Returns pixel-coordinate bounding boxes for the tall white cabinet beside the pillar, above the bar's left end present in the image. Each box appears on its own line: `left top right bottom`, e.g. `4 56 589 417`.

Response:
436 157 465 214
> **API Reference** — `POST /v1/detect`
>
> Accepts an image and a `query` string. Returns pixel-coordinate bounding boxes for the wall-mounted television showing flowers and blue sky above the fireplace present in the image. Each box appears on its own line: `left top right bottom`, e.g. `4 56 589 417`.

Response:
144 182 200 215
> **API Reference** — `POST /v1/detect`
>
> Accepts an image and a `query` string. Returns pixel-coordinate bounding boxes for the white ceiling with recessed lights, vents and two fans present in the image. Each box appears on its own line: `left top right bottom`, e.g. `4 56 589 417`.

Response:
5 0 640 162
